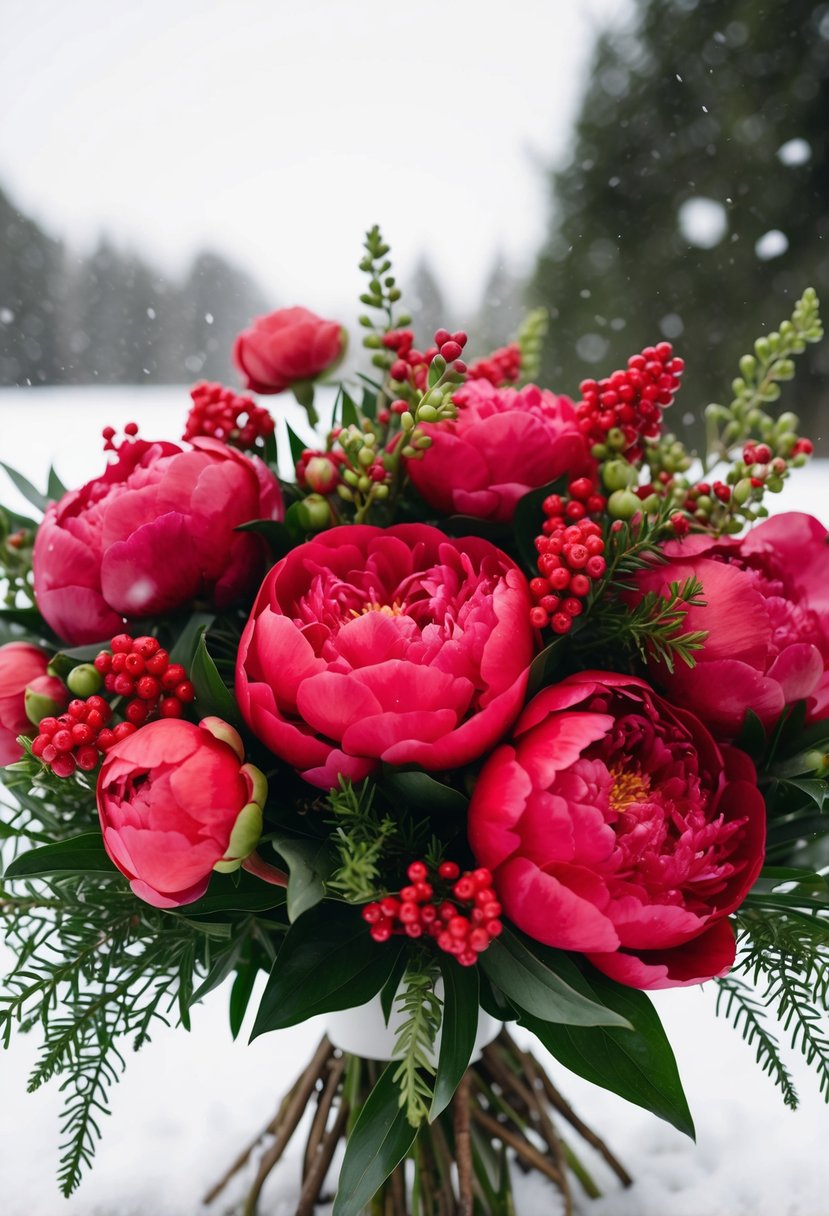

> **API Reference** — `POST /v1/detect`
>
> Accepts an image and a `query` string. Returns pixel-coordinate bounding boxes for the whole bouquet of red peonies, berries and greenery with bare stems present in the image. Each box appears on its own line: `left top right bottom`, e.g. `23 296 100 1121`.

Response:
0 229 829 1216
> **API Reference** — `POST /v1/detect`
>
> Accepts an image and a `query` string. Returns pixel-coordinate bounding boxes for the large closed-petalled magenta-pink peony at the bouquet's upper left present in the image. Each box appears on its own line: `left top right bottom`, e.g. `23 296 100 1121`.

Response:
33 439 282 646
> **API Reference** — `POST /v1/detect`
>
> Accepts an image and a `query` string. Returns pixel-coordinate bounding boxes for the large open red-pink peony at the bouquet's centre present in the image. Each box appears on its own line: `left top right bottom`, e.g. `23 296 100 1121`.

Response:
236 524 535 789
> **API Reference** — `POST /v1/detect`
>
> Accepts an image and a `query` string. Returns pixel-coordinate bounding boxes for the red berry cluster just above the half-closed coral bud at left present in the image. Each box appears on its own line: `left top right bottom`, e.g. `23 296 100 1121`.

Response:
95 634 196 727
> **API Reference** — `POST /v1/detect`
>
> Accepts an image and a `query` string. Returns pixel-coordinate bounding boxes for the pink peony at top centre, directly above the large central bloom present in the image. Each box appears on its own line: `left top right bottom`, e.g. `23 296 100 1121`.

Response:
406 379 592 520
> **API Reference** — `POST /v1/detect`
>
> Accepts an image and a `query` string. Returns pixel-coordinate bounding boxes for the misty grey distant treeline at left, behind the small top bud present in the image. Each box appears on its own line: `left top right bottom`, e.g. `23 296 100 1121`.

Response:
0 184 266 385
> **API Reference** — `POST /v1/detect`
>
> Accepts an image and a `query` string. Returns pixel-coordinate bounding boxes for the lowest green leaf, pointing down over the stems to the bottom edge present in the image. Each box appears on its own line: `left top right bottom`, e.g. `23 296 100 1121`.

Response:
333 1063 417 1216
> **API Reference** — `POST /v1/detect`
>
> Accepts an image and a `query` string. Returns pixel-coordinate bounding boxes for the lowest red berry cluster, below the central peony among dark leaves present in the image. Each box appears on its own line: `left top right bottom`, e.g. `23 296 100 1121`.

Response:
362 861 503 967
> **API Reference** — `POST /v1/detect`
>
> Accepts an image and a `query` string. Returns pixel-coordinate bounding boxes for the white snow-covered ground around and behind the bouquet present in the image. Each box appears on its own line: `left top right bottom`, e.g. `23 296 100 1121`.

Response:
0 388 829 1216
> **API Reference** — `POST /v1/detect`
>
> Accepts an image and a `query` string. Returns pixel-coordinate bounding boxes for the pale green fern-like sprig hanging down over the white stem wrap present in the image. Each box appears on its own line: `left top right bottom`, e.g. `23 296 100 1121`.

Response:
394 959 442 1127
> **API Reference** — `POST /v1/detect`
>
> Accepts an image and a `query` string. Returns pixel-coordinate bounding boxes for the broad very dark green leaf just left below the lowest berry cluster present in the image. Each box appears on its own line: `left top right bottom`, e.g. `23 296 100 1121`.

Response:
250 902 404 1038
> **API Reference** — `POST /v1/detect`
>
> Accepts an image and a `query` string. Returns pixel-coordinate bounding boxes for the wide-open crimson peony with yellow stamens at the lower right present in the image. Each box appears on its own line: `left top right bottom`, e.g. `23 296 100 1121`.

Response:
469 671 766 989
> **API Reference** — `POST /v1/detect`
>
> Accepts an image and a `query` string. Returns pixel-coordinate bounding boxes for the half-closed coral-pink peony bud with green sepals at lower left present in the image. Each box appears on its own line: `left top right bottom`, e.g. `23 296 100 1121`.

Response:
97 717 267 908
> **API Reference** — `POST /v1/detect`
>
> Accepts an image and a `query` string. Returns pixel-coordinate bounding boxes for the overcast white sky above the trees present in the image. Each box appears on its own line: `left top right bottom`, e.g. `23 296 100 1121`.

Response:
0 0 628 311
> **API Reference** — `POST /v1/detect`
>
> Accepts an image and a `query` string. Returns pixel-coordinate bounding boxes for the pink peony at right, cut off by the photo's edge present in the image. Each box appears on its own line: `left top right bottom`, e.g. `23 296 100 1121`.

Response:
637 512 829 738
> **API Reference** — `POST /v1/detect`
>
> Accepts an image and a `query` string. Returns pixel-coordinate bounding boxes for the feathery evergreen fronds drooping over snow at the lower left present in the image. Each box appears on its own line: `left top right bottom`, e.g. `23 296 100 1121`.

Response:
0 876 208 1195
